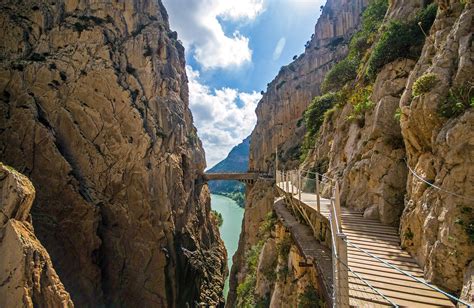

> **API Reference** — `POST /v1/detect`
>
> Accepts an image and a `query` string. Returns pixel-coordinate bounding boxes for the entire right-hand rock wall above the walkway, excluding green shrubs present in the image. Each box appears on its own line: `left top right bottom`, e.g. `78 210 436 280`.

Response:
246 0 474 301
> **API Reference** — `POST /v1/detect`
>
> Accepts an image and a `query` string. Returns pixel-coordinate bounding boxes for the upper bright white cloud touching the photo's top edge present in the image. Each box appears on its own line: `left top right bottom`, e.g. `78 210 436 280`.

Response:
164 0 265 69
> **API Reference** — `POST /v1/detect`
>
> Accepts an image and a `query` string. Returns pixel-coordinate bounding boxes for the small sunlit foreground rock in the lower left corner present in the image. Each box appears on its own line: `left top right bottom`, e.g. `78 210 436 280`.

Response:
0 163 74 308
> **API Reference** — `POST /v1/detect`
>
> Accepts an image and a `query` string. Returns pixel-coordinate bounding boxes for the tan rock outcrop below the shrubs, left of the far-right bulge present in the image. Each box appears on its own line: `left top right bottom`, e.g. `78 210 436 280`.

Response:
302 59 414 224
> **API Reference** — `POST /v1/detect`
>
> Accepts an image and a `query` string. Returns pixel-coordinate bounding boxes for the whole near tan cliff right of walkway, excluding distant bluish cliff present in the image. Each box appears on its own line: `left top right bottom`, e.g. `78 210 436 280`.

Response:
303 1 474 294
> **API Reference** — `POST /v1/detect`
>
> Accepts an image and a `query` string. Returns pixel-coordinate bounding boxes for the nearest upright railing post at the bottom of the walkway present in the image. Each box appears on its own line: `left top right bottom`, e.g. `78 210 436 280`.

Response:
337 233 349 307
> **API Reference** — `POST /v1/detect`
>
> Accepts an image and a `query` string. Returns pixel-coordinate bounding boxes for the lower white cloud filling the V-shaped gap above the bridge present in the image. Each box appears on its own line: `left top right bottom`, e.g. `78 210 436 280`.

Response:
186 65 262 167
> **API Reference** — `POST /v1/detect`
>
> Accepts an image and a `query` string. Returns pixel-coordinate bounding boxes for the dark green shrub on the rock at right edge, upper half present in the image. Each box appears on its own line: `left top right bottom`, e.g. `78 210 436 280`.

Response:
438 85 474 118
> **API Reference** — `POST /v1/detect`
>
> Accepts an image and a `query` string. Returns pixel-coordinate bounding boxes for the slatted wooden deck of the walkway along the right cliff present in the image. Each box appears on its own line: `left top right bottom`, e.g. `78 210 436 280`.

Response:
277 182 455 307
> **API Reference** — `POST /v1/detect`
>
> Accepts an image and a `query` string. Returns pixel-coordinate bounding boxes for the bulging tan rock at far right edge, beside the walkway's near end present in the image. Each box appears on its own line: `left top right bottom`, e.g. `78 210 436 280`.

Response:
400 1 474 294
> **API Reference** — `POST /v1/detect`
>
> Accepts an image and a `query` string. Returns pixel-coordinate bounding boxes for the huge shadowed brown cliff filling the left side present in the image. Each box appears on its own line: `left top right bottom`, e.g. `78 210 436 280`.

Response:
0 0 226 307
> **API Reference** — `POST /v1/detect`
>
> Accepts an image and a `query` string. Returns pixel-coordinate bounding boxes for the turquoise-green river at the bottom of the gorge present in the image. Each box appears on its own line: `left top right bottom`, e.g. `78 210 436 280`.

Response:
211 194 244 298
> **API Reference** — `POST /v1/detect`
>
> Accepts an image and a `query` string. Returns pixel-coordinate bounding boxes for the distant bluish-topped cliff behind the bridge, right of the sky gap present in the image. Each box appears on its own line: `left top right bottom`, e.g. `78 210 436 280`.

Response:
249 0 367 171
